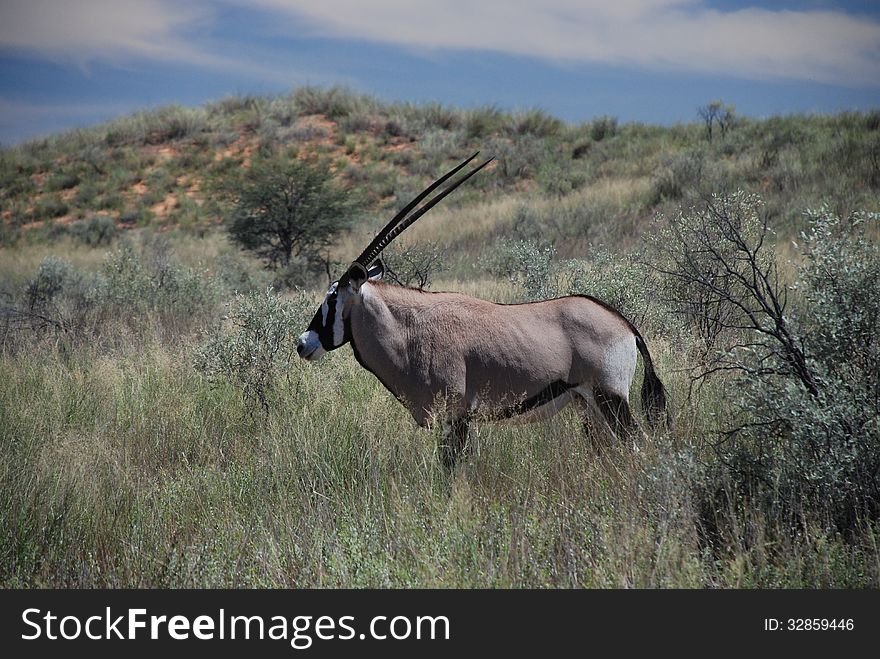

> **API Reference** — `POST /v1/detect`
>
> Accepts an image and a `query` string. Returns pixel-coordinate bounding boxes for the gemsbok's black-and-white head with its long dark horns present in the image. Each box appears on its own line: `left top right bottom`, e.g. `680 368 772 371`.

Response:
296 151 493 360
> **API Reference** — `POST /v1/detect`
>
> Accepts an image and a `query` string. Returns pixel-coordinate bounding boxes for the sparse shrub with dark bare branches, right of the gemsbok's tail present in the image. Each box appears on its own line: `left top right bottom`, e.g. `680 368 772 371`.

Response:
653 192 817 386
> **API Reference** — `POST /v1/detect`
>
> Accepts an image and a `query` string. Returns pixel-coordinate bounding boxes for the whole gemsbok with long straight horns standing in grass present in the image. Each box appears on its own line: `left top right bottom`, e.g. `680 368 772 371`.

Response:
296 152 667 471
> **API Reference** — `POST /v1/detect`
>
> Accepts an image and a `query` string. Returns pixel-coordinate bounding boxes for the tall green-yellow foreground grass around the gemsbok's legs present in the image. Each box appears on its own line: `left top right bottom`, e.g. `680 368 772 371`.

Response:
0 328 878 587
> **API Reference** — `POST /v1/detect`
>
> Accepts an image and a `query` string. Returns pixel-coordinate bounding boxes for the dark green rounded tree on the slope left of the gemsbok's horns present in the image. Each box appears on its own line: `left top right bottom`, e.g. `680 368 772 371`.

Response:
227 158 354 270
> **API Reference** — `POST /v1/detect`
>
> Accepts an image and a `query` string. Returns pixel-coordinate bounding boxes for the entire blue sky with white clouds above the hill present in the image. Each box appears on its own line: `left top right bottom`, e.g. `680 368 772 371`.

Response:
0 0 880 145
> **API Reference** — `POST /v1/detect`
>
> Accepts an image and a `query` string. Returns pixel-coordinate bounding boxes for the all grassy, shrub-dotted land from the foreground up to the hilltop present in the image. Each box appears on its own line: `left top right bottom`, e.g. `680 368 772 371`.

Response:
0 88 880 587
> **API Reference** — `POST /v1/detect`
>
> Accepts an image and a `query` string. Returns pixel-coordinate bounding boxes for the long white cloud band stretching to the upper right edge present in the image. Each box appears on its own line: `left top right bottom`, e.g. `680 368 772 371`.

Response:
249 0 880 86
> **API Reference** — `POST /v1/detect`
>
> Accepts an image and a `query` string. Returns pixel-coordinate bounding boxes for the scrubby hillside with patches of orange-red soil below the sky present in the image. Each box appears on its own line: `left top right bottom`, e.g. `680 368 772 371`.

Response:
0 87 880 257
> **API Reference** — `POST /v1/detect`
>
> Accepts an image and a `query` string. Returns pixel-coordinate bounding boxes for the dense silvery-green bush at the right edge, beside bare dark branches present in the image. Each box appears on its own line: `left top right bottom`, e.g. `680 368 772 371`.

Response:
739 208 880 531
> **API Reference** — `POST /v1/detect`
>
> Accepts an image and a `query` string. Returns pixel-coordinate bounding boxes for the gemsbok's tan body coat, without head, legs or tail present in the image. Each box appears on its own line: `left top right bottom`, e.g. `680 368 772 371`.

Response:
343 282 637 425
